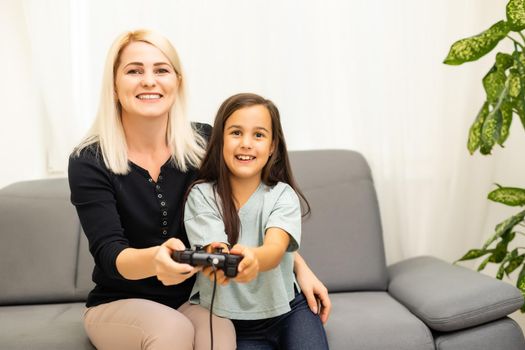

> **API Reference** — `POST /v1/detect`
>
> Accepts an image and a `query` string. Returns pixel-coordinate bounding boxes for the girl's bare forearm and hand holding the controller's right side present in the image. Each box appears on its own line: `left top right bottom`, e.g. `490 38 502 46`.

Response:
230 227 290 282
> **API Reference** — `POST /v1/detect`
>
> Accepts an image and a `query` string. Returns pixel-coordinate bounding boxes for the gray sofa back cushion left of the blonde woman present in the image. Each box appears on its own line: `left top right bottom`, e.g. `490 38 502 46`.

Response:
0 179 93 305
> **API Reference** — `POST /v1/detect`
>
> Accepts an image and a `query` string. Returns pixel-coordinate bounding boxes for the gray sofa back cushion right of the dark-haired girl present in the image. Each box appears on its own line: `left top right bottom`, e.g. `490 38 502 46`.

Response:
290 150 388 292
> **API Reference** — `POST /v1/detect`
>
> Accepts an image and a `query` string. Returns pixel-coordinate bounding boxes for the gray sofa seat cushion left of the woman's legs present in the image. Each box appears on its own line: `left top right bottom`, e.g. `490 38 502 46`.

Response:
0 303 95 350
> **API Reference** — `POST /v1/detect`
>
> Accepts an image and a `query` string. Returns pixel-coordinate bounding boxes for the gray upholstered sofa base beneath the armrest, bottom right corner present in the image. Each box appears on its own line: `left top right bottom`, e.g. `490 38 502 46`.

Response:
435 317 525 350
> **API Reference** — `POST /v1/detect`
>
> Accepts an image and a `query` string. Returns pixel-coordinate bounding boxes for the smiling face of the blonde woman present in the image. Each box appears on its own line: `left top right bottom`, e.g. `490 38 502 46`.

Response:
115 41 179 118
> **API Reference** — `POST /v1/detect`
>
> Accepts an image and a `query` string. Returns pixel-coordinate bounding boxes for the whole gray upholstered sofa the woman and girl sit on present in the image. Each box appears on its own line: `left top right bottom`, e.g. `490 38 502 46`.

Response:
0 150 525 350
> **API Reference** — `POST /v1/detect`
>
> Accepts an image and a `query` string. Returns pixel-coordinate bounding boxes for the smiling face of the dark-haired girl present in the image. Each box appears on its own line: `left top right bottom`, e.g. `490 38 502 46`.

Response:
222 105 274 186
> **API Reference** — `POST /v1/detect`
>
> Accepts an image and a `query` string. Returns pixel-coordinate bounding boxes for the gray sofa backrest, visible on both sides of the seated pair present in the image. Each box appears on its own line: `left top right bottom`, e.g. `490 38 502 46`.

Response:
0 150 387 305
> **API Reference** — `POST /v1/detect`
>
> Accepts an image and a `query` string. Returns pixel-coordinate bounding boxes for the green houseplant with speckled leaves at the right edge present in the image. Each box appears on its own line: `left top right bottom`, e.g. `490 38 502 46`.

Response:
444 0 525 312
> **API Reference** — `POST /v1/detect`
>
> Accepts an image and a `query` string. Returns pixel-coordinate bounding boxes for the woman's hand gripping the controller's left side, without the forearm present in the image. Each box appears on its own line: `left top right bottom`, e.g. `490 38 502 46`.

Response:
154 238 200 286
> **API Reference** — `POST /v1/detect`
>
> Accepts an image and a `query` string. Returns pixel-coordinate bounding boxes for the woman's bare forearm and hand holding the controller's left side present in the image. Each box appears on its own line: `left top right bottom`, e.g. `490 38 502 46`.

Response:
116 238 199 286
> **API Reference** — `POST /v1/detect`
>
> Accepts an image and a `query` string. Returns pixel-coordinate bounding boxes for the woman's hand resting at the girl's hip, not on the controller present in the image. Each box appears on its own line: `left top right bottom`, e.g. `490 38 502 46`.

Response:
294 253 332 324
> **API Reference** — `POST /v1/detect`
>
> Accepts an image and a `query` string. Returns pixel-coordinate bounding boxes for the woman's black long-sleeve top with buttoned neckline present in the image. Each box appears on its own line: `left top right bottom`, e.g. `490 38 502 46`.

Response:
68 124 211 308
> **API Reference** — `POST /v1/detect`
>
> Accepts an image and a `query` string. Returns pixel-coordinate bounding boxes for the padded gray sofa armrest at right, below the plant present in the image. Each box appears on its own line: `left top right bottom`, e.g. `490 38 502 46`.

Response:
388 256 523 331
